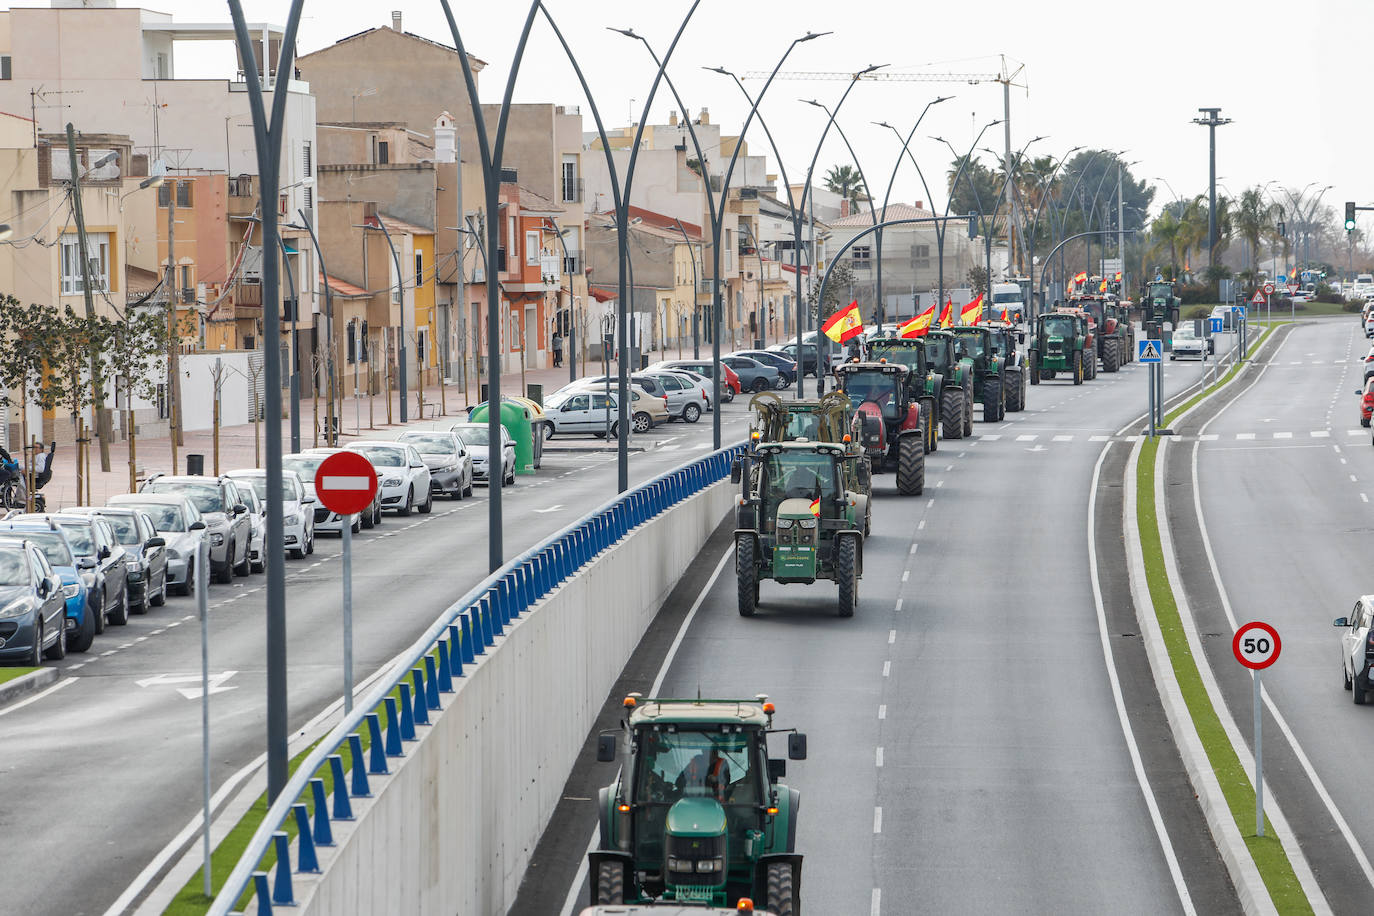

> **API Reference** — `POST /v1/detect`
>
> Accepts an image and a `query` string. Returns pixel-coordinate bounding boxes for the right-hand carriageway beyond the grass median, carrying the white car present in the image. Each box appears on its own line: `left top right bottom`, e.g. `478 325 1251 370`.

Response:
1167 316 1374 913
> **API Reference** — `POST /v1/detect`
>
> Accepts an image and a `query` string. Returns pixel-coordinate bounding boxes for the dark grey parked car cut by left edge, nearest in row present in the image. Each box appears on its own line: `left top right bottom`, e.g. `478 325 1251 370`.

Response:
0 538 67 667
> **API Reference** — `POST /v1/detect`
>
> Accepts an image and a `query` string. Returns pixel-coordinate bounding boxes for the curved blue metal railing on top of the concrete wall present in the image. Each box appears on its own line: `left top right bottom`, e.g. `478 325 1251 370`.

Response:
209 444 745 916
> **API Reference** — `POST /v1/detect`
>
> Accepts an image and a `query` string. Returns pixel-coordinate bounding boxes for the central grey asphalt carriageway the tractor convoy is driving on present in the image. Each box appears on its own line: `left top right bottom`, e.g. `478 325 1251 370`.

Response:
527 333 1238 916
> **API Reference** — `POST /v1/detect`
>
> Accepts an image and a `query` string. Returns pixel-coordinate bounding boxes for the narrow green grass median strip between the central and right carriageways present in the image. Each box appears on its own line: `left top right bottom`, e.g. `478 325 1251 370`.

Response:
1135 322 1312 916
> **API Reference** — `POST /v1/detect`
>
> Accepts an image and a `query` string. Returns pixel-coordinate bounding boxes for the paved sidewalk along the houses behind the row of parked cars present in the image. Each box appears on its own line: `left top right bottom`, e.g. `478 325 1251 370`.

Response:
43 363 585 511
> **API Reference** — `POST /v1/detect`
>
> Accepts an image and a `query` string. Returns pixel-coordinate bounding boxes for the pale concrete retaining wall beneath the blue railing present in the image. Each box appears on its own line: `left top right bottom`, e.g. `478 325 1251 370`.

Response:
285 481 734 916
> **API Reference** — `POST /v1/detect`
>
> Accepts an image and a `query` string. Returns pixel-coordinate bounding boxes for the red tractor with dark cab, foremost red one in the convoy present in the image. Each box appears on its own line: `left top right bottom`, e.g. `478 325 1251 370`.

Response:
835 363 930 496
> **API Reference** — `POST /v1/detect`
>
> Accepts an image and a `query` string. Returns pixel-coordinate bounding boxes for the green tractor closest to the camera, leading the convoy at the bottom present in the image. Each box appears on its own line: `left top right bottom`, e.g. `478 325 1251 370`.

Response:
588 694 807 916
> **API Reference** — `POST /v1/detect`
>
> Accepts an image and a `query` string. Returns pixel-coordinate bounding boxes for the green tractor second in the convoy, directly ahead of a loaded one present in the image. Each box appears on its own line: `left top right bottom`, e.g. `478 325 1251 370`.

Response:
730 442 863 617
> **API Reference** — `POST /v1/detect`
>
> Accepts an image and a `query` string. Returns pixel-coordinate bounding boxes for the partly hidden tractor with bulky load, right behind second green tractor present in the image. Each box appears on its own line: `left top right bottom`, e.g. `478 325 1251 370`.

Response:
749 391 872 537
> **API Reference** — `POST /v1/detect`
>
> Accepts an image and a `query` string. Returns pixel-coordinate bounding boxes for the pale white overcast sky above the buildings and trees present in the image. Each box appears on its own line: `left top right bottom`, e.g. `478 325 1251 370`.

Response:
91 0 1374 228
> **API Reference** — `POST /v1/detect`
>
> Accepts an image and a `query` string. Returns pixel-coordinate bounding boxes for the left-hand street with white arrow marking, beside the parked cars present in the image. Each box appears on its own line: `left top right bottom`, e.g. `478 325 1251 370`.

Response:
0 398 747 916
